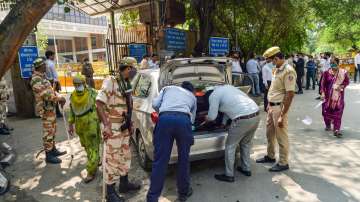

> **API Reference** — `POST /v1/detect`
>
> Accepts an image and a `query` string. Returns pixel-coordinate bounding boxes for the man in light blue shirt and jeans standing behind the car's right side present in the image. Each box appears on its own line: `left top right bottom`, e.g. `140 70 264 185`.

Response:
246 52 261 96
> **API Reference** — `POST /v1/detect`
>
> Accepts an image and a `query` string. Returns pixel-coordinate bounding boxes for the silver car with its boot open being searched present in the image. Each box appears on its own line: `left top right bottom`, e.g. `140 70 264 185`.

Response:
132 58 250 170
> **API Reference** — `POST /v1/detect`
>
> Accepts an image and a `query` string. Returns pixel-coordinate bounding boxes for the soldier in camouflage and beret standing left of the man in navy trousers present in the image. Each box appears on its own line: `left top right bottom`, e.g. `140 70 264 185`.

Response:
96 58 140 202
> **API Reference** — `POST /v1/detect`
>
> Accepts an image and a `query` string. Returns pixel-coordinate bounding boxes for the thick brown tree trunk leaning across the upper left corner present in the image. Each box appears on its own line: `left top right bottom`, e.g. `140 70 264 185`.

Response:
0 0 56 78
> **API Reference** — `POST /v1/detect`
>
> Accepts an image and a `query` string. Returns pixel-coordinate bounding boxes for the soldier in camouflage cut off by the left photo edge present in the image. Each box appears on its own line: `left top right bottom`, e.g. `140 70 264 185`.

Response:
0 78 11 135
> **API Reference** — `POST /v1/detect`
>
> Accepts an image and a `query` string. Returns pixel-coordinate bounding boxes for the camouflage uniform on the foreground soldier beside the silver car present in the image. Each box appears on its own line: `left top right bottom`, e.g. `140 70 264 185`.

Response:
96 76 131 184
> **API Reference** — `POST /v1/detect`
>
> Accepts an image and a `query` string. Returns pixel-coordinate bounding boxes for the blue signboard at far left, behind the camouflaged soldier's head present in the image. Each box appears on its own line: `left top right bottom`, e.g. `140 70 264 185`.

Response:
18 46 38 79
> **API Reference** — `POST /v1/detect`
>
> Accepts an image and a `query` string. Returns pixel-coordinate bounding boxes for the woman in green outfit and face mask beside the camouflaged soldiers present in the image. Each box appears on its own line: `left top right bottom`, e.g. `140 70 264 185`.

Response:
68 75 100 183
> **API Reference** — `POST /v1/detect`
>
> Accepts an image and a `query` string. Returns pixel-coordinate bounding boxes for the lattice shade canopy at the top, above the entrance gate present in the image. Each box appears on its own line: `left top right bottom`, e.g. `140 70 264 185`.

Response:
74 0 150 16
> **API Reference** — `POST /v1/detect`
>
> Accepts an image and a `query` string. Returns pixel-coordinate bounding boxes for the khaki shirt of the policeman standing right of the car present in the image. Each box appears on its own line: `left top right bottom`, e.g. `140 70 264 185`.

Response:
268 63 296 103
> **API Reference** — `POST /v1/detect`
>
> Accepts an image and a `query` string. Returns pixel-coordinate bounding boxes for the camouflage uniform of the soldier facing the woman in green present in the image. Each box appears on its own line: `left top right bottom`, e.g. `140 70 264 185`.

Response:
30 71 57 152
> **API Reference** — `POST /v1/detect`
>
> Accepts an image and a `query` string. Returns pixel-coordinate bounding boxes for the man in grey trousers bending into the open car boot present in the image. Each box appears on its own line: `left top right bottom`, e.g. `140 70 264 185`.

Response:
206 85 260 182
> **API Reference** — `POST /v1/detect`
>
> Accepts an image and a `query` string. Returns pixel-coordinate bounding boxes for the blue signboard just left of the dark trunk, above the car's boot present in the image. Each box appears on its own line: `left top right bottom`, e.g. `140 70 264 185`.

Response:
165 28 186 51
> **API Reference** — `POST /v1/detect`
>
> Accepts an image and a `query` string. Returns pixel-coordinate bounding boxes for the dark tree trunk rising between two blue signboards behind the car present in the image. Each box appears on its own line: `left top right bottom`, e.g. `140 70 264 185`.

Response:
192 0 216 56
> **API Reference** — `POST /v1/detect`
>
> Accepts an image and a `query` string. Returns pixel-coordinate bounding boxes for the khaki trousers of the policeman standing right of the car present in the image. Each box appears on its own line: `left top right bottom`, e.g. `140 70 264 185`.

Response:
266 106 289 165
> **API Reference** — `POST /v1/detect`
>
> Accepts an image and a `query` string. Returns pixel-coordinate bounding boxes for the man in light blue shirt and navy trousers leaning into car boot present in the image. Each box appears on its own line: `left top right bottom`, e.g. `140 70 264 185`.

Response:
147 81 197 202
